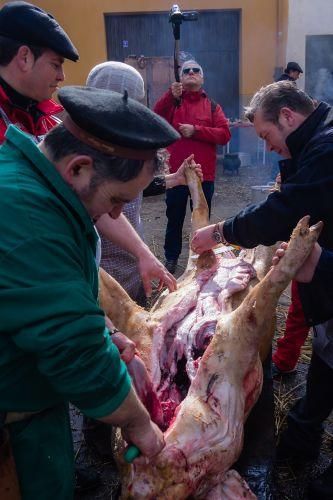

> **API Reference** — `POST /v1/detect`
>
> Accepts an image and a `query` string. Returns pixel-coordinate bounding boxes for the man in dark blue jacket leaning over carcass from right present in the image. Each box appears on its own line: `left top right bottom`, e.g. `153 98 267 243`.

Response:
192 82 333 325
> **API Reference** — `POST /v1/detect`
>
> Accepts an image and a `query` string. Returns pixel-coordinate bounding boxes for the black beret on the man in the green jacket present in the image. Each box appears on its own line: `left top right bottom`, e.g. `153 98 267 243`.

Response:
58 86 180 159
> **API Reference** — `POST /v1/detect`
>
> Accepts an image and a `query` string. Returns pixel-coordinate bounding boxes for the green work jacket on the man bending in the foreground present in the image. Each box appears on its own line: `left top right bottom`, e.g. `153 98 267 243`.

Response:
0 126 131 418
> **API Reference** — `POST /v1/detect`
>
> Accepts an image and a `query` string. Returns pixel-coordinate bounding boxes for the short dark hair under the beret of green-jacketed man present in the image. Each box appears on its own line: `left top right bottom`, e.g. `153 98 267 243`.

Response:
44 124 157 187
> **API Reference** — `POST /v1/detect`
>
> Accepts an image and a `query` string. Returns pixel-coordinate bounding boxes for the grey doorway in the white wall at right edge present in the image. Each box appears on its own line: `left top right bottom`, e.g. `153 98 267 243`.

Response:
305 35 333 104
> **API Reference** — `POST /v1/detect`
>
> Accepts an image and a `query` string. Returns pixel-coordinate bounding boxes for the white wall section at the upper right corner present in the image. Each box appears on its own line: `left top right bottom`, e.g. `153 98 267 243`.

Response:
286 0 333 88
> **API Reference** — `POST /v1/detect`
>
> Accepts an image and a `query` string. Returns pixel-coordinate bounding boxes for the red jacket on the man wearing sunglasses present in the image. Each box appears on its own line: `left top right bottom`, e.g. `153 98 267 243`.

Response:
154 89 231 181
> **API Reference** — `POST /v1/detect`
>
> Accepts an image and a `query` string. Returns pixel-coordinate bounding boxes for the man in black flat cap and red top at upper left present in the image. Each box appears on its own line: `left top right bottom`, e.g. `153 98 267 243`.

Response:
0 1 79 143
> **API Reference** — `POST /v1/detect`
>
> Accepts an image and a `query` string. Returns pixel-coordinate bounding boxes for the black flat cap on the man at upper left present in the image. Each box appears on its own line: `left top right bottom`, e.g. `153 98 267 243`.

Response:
0 2 79 61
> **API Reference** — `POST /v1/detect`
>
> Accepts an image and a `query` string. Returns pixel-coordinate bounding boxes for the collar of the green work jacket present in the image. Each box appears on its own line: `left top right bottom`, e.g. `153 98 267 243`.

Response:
2 125 97 244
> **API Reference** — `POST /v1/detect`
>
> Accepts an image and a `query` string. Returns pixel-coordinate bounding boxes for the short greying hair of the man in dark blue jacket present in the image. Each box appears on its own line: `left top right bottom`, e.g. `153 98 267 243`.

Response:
245 81 315 124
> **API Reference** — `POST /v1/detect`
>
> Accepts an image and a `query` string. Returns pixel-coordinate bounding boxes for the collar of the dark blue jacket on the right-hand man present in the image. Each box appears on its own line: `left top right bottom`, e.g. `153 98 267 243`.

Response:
286 102 331 159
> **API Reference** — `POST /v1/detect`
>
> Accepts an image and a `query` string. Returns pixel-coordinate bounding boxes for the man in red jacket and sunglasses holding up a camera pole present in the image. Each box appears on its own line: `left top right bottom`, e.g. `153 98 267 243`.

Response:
154 60 231 273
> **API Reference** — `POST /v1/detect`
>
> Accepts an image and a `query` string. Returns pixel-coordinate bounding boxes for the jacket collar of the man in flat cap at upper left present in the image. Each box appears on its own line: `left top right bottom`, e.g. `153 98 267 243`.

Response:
0 81 64 115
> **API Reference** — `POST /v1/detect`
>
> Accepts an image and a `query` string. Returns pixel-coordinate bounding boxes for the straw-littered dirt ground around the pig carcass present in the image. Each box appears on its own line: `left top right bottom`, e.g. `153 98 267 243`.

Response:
72 161 333 500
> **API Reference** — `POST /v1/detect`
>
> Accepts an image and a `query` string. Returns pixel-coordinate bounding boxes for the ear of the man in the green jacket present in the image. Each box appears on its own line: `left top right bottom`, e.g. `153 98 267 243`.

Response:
62 155 94 189
